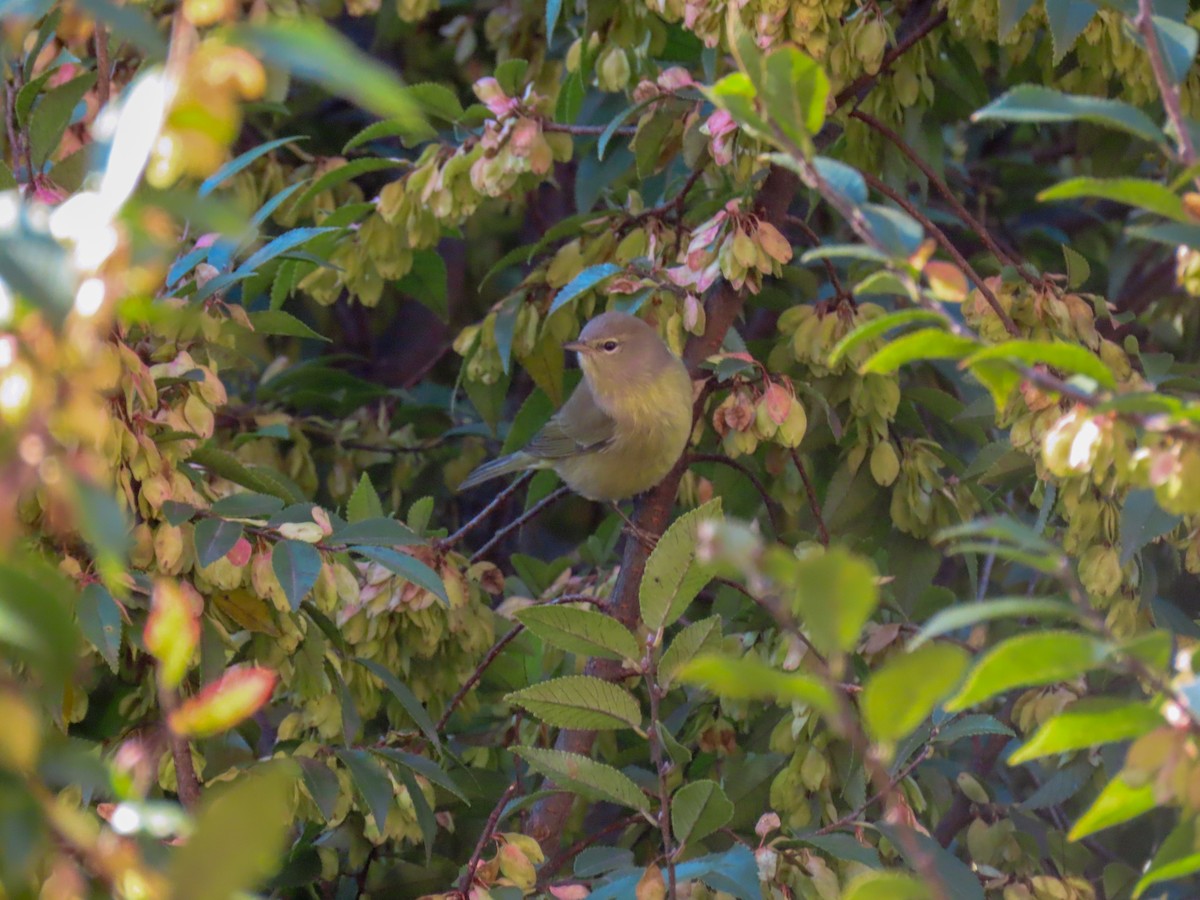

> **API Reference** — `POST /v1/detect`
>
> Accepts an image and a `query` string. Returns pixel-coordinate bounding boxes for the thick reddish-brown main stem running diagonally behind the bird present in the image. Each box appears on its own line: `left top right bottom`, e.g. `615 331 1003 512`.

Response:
526 167 798 847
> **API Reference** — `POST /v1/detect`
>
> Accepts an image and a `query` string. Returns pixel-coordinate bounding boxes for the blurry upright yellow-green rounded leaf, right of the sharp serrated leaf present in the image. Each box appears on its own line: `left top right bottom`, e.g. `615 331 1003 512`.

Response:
791 547 880 653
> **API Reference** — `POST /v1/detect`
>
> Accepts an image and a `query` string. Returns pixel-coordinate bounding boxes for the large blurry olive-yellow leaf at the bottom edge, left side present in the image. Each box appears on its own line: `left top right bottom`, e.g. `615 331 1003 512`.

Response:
169 763 295 900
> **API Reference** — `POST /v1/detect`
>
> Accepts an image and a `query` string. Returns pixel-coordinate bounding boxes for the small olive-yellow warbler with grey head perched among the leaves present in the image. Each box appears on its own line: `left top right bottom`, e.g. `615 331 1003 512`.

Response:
458 312 692 502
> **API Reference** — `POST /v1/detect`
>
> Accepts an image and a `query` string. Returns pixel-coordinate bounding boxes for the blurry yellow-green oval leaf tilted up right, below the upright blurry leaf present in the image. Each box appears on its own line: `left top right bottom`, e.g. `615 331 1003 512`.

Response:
860 643 968 740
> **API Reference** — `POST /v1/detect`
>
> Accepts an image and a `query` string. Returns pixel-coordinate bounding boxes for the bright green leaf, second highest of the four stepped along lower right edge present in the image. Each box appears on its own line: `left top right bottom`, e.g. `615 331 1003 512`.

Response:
1008 697 1164 766
